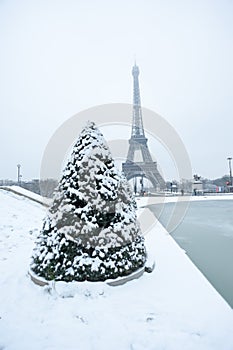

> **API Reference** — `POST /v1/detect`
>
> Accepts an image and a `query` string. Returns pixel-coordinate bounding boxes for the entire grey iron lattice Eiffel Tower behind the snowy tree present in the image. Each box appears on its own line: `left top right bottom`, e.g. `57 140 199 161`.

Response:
122 63 165 192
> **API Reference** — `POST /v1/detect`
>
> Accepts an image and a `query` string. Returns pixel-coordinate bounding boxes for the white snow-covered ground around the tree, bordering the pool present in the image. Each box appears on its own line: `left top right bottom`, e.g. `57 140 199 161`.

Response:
0 190 233 350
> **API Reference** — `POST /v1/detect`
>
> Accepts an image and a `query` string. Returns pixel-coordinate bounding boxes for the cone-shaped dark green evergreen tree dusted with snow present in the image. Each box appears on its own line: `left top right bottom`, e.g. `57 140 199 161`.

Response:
31 122 146 281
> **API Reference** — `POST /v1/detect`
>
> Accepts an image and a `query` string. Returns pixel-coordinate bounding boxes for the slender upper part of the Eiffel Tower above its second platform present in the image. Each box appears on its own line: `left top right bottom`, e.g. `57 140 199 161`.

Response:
131 62 145 139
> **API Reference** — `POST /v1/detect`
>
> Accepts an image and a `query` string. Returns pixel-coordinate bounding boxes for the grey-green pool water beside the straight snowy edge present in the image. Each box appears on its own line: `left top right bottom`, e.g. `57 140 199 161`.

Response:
149 200 233 308
